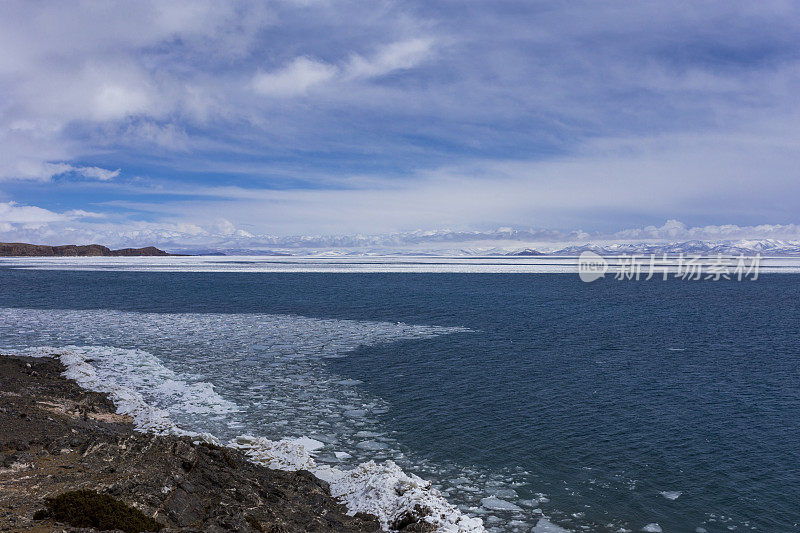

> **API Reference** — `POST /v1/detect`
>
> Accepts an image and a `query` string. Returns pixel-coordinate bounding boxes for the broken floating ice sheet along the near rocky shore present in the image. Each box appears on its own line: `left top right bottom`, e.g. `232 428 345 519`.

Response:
0 308 572 531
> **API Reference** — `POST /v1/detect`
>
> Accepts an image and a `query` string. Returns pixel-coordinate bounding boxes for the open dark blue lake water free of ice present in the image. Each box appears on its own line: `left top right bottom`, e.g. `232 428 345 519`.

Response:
0 270 800 532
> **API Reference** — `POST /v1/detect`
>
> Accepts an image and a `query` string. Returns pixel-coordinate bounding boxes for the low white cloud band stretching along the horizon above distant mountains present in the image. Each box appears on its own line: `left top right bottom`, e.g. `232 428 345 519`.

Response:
0 203 800 253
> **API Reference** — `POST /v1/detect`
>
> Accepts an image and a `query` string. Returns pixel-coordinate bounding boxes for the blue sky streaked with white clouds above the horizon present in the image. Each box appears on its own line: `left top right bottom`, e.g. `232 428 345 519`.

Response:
0 0 800 248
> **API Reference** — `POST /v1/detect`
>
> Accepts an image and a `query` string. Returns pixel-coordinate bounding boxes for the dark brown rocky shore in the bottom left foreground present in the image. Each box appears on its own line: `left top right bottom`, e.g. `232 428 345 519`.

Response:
0 356 388 533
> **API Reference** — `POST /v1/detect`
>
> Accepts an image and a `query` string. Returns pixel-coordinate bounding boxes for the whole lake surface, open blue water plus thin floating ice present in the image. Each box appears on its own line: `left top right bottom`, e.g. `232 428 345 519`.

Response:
0 271 800 532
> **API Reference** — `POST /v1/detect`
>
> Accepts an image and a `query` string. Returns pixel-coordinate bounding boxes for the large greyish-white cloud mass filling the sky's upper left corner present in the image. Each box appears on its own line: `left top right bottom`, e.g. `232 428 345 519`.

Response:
0 0 272 180
